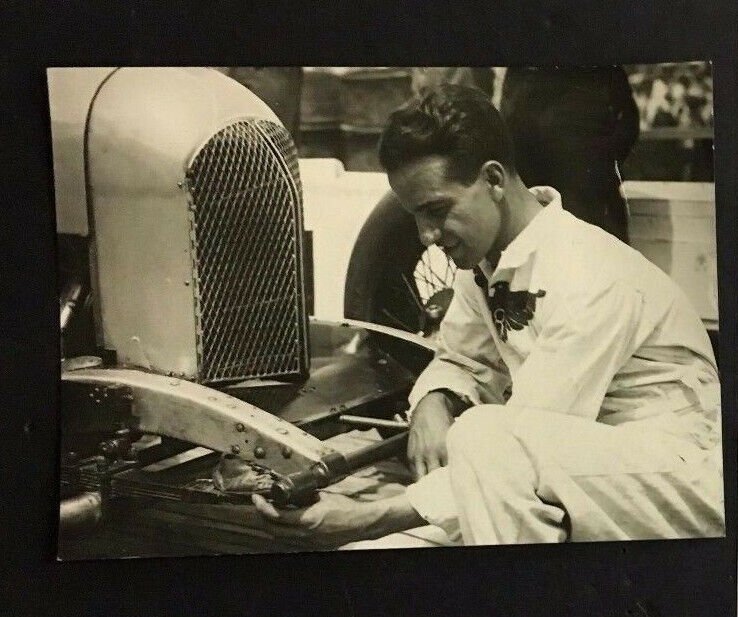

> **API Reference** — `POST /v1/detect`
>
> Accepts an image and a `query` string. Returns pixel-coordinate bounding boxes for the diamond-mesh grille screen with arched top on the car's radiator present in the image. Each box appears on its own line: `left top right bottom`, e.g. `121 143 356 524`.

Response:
187 120 308 383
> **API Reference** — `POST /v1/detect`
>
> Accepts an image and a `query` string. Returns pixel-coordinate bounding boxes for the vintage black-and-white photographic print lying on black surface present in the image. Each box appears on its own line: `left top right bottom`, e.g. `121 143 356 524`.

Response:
53 61 725 560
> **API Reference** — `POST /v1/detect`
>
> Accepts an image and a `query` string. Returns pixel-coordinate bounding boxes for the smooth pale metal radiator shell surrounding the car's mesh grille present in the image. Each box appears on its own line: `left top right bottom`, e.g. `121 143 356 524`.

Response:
85 68 307 383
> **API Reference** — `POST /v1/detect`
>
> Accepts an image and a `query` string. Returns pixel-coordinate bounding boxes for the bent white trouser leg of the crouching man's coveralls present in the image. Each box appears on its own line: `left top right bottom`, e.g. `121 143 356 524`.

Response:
447 405 725 544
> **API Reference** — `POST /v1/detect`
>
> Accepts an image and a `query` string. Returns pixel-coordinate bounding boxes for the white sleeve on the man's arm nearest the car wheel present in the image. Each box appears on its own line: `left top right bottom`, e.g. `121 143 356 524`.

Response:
408 270 510 416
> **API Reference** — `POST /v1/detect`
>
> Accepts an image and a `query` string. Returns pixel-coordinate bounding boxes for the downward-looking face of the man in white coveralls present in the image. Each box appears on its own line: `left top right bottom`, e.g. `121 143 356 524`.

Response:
388 156 500 270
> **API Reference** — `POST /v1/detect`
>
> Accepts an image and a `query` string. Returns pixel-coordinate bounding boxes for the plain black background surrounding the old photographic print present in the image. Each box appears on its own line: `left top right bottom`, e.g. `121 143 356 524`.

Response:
0 0 738 617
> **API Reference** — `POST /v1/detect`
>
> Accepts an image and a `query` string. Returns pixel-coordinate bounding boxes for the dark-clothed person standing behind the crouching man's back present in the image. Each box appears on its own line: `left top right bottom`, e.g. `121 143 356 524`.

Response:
500 67 639 243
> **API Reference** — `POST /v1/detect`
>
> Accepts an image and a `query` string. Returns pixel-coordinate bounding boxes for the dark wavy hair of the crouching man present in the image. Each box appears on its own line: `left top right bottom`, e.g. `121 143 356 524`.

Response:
379 84 514 185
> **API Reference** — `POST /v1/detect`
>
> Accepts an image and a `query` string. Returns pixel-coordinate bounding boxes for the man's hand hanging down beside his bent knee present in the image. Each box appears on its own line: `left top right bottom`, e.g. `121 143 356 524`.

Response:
407 392 454 479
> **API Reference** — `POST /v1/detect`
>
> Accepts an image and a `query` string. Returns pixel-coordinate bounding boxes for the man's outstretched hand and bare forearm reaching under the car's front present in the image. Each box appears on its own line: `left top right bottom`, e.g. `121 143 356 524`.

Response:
252 493 426 548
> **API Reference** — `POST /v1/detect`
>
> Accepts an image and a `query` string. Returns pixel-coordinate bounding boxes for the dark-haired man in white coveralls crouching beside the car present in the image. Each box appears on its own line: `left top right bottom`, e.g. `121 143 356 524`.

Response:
254 85 725 546
